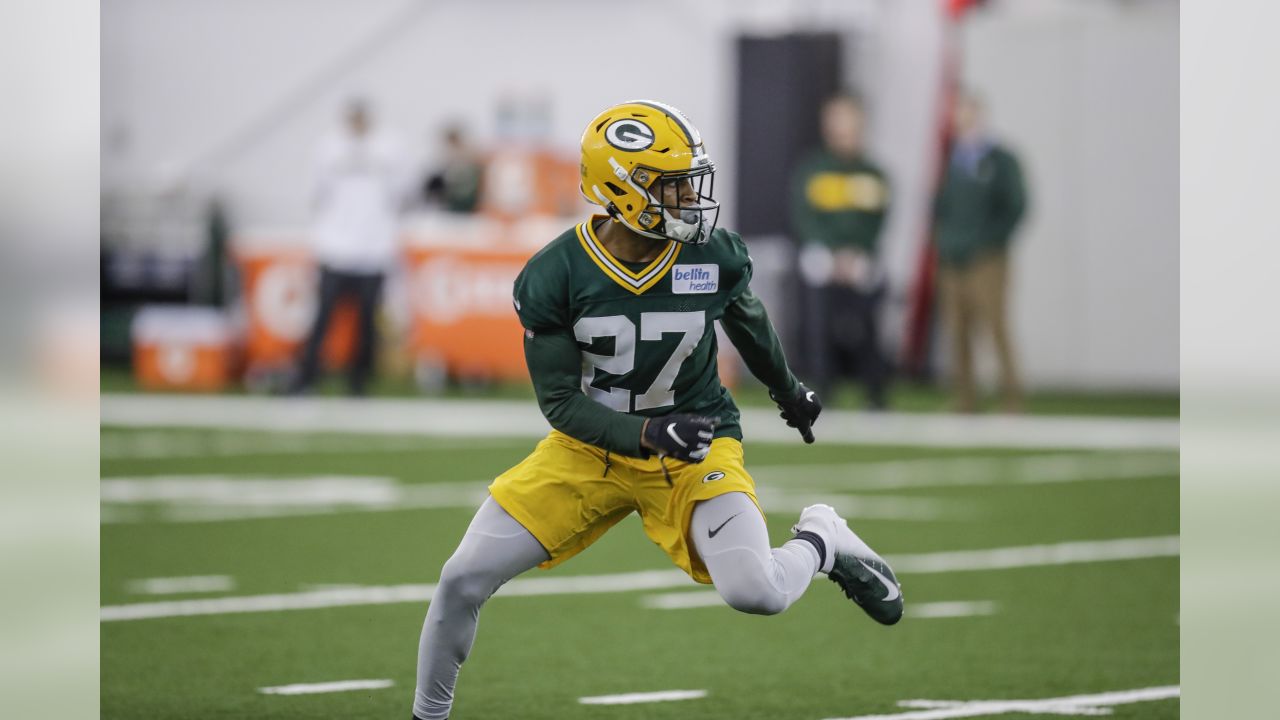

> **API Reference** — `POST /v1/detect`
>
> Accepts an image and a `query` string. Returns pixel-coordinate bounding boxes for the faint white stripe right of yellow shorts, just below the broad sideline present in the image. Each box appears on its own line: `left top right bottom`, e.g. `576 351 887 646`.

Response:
750 452 1179 491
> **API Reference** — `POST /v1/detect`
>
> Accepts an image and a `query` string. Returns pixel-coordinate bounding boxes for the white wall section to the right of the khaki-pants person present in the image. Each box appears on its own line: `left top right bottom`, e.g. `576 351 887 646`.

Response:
964 3 1179 389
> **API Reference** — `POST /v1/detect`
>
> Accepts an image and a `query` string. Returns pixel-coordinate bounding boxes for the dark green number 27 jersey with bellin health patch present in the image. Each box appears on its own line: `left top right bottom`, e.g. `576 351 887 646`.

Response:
515 217 799 456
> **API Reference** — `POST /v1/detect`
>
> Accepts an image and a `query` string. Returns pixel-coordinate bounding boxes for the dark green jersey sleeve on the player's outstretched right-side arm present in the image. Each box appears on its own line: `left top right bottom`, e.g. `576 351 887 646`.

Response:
721 233 800 396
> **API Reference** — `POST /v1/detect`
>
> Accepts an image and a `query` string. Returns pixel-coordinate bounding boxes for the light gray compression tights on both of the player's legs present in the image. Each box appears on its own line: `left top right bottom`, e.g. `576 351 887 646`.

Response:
413 492 820 720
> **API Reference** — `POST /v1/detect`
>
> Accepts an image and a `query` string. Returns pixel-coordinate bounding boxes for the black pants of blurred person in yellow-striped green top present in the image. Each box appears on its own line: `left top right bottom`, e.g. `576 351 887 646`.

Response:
804 284 890 409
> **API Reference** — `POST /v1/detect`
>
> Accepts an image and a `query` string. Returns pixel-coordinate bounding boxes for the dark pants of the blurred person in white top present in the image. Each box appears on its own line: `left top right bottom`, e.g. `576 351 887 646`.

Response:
293 265 383 395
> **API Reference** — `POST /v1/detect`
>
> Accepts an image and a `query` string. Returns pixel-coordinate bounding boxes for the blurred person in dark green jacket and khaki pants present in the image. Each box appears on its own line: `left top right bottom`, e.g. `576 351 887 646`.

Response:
934 92 1027 413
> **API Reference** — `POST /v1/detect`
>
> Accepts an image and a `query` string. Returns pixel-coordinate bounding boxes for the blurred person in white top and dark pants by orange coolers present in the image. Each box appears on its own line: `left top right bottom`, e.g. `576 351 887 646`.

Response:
289 100 406 396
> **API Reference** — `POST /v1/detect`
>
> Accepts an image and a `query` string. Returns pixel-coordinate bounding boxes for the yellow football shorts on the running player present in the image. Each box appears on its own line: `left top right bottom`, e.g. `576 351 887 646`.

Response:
489 430 763 583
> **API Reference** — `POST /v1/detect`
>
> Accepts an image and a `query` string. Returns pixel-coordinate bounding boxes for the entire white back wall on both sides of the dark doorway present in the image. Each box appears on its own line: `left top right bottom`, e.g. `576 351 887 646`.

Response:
101 0 1178 387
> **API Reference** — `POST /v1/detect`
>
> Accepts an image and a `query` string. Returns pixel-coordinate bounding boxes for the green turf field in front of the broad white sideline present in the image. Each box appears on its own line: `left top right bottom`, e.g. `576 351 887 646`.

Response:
101 427 1179 720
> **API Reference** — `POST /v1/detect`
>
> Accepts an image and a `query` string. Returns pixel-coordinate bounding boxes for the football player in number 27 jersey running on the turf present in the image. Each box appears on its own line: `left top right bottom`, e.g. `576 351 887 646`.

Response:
413 100 902 720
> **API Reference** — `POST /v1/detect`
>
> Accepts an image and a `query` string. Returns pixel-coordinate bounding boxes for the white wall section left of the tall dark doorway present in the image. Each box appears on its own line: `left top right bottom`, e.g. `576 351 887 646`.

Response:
102 0 773 223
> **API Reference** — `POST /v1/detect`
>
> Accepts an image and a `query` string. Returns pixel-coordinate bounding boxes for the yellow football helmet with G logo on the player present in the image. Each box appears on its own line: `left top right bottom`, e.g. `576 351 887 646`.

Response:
580 100 719 245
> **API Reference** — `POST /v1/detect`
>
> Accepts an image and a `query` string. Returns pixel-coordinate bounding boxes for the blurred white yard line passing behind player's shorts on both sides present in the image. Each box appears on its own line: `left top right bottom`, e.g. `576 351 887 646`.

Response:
100 452 1178 524
